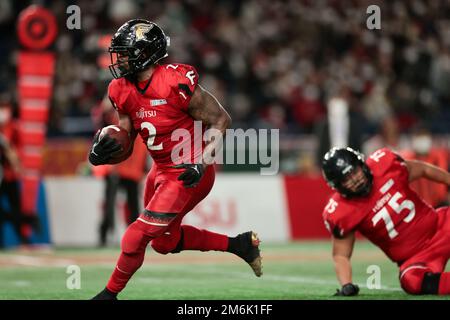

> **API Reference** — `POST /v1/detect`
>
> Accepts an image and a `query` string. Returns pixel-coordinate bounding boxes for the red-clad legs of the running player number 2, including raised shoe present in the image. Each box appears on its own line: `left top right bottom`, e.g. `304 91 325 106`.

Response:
94 166 261 300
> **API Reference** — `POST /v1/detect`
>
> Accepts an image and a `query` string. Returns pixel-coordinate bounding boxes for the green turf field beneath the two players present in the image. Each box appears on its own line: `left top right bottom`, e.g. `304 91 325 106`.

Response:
0 242 447 300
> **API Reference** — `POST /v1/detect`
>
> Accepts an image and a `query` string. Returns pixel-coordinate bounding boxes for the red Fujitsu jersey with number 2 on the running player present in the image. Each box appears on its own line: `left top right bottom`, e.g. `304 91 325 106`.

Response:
108 64 205 167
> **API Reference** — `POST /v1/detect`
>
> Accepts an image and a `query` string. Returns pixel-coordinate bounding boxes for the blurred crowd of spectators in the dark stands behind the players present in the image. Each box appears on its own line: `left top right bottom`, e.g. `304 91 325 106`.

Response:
0 0 450 164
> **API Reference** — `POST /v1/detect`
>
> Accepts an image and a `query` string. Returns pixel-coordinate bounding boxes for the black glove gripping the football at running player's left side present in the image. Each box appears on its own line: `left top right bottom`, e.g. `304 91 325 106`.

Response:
89 130 122 166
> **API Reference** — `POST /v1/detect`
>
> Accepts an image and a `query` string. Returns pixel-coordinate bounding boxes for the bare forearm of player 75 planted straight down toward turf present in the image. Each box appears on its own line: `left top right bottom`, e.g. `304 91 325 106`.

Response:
333 233 355 285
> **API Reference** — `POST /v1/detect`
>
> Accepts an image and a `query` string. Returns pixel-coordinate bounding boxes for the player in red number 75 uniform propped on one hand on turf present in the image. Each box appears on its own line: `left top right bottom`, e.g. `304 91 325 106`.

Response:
322 148 450 296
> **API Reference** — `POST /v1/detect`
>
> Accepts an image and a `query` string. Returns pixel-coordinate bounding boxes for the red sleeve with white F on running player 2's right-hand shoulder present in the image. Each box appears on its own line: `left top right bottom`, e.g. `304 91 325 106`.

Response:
164 64 198 110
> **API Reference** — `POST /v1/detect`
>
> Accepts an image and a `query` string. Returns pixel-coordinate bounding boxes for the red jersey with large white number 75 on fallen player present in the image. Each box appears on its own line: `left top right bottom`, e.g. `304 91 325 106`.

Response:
323 148 438 263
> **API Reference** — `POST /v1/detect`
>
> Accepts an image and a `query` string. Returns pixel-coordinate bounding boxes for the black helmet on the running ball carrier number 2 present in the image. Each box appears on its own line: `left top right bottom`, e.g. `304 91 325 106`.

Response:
108 19 170 79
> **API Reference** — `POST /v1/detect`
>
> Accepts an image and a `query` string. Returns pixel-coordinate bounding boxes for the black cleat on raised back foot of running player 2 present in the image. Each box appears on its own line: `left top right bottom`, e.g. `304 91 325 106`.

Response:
228 231 262 277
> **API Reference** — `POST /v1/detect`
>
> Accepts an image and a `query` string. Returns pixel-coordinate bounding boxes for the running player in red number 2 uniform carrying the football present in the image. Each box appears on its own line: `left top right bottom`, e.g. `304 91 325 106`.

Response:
89 19 262 299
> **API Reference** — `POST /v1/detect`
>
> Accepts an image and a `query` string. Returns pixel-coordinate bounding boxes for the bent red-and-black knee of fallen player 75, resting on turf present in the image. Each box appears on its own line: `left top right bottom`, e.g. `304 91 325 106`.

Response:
400 265 441 294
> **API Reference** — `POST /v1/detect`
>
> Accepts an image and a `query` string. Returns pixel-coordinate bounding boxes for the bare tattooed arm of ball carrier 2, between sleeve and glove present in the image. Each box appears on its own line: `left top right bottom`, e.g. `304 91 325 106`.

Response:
188 85 231 165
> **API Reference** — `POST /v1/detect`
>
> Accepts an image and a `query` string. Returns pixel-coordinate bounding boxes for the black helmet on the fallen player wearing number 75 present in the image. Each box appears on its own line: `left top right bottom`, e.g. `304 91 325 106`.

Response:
322 147 373 198
